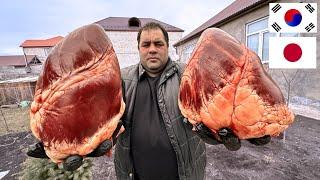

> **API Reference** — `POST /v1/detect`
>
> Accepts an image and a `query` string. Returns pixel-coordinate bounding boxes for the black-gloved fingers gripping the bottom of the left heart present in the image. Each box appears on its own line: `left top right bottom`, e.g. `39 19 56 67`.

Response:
27 120 124 171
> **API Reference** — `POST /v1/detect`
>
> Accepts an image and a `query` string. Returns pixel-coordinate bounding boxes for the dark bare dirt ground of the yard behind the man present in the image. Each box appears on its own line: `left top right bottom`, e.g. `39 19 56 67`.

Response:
0 109 320 180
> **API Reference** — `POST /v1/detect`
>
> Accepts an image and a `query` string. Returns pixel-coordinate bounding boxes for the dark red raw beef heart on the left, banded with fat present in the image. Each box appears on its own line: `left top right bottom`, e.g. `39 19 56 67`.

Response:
30 25 125 162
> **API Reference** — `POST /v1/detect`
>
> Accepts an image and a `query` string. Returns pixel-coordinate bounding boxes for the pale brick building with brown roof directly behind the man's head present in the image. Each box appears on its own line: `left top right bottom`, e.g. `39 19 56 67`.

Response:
95 17 183 68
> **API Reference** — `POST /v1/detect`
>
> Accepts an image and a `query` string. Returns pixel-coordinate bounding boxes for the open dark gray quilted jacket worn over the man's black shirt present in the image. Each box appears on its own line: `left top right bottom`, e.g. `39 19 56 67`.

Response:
114 59 206 180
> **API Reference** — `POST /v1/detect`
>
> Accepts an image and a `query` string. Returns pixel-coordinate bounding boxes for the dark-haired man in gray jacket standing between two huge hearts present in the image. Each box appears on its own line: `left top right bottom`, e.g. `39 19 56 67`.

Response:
114 23 206 180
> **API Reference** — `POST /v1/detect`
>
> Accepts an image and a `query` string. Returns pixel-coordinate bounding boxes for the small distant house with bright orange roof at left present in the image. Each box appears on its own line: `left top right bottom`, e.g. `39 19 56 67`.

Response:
20 36 63 62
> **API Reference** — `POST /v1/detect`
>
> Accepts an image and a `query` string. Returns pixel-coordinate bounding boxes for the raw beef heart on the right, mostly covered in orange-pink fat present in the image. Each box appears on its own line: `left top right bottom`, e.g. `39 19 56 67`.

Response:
179 28 294 139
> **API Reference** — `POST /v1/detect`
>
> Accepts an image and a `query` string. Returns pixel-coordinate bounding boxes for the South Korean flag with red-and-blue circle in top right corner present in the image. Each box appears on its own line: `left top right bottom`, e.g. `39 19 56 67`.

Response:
269 3 317 33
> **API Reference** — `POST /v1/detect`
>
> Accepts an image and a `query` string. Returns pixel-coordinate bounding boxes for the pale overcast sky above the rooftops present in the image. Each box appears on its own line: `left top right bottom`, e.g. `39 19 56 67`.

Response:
0 0 234 55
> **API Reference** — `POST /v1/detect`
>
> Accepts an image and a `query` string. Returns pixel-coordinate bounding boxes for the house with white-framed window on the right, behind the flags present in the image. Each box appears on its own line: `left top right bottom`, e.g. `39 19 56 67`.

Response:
174 0 320 119
